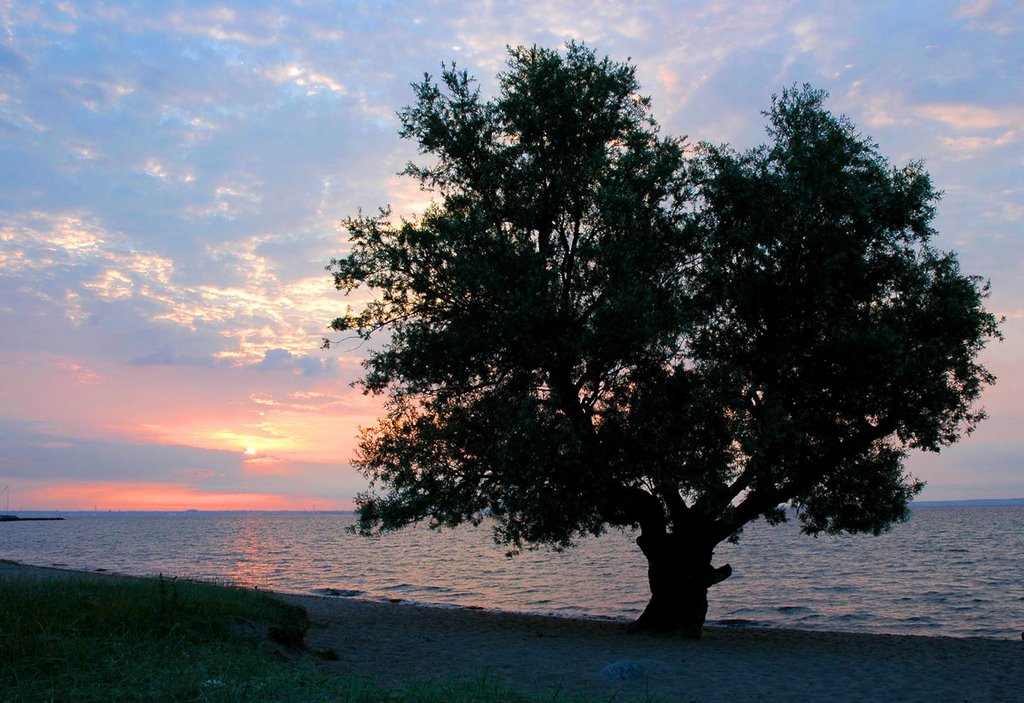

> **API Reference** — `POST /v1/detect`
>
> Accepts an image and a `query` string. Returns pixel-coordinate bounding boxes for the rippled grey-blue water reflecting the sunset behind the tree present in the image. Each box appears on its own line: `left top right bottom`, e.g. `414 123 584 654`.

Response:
0 506 1024 640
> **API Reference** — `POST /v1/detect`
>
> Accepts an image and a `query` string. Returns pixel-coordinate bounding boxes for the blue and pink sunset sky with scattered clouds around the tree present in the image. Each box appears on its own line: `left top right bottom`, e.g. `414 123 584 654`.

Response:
0 0 1024 511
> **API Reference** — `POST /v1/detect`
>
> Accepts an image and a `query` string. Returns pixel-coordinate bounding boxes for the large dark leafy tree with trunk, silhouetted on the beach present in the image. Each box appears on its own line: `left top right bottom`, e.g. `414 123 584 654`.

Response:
327 43 998 638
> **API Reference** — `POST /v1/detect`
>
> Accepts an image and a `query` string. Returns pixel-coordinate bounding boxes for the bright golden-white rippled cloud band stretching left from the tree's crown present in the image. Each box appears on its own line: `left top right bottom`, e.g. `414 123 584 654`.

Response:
0 213 348 374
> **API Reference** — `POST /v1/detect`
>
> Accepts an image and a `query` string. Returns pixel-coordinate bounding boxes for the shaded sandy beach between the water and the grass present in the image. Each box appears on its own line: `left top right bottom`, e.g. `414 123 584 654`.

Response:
0 562 1024 703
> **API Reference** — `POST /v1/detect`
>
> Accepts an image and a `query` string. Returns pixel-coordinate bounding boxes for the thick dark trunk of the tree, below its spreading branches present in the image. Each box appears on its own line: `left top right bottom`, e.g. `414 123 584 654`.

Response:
633 532 732 640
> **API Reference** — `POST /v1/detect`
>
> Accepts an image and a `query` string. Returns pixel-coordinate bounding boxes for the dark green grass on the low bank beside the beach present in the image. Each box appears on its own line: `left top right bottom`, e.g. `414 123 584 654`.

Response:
0 577 663 703
